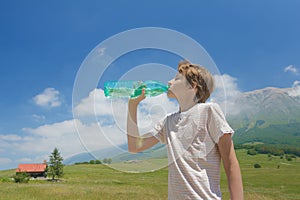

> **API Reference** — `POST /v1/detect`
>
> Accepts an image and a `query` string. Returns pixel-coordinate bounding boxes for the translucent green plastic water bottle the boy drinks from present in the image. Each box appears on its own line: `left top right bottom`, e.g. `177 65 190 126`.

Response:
104 80 169 98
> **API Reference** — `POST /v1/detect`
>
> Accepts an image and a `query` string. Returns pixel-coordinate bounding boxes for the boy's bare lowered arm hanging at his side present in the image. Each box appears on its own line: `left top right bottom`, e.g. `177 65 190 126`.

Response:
218 134 244 200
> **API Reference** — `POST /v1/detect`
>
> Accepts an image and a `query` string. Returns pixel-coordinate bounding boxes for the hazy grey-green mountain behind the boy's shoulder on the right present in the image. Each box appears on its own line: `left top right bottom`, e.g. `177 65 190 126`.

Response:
228 87 300 146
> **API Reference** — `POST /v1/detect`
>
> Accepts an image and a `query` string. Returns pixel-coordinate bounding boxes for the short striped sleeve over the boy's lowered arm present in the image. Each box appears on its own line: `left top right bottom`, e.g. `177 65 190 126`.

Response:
208 103 234 143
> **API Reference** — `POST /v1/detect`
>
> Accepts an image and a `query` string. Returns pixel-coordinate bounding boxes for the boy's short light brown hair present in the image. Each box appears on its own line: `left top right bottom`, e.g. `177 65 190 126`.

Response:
178 60 214 103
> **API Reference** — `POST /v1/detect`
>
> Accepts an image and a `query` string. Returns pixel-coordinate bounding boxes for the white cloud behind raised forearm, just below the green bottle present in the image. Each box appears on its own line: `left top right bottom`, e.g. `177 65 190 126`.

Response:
73 89 177 127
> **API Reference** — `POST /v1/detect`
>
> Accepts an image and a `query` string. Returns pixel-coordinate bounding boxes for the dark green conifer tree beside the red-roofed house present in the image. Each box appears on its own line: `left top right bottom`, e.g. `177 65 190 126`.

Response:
48 147 64 180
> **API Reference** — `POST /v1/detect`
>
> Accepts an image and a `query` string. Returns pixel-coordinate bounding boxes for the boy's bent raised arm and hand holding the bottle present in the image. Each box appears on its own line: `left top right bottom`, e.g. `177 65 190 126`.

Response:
127 90 158 153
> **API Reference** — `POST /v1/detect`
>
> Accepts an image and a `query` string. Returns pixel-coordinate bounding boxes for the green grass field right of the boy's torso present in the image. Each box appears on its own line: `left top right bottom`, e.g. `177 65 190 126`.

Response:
226 150 300 200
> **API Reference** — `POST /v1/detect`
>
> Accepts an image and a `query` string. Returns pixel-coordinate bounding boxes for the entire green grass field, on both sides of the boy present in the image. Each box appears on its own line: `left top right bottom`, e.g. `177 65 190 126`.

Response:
0 150 300 200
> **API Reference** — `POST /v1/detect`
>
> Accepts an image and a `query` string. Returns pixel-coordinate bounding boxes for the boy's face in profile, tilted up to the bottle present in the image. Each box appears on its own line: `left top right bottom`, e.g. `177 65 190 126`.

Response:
168 73 193 99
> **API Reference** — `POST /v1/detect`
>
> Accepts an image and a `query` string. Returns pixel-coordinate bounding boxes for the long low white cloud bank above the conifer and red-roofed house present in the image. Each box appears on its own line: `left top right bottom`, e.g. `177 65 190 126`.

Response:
0 117 126 169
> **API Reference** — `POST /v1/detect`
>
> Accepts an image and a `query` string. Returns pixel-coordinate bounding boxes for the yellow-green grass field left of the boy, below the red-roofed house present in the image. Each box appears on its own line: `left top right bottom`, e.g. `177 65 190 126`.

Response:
0 162 168 200
